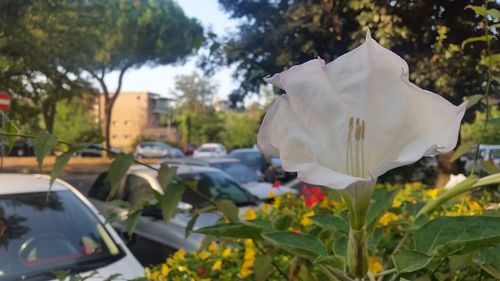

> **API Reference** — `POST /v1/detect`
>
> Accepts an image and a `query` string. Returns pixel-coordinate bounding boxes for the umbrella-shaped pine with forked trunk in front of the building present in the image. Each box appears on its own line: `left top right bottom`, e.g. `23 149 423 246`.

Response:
85 0 203 152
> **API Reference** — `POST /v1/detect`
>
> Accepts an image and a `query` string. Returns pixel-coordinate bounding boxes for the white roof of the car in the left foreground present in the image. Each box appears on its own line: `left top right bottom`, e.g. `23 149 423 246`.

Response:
0 173 68 195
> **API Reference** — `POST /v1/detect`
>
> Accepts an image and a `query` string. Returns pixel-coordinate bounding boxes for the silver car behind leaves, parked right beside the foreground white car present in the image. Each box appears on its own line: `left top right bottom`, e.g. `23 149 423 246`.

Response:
88 165 257 265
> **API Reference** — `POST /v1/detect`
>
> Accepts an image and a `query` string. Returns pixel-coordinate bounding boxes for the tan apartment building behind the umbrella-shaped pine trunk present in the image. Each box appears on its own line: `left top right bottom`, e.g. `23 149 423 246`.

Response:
97 92 180 152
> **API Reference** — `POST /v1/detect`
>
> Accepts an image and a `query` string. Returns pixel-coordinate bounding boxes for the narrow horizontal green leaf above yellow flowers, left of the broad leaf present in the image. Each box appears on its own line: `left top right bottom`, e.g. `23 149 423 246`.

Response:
194 222 264 240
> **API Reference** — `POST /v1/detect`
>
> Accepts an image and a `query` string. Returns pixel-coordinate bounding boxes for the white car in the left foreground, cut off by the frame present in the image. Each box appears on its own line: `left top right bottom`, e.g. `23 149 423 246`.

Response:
0 174 144 280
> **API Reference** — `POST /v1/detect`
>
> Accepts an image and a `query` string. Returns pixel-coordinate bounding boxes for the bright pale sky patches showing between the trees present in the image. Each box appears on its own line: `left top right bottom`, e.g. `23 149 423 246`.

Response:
105 0 238 99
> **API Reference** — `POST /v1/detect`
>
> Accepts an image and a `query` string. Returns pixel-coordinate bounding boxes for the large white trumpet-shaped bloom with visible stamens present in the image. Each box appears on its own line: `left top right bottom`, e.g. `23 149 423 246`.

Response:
258 32 466 191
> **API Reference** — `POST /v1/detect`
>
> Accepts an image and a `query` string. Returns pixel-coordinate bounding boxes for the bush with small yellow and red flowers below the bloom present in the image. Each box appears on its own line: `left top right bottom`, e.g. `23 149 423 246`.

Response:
146 179 500 281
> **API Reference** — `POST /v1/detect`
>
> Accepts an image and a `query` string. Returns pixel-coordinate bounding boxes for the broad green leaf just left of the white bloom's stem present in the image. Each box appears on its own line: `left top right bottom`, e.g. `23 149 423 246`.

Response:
262 231 328 259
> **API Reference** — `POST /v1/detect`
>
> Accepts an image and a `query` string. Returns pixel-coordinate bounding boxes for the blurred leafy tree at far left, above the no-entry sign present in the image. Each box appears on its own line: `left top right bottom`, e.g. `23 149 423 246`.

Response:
0 0 96 132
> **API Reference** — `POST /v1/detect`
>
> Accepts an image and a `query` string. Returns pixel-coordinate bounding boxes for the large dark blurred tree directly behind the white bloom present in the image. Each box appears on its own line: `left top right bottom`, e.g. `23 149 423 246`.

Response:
211 0 500 109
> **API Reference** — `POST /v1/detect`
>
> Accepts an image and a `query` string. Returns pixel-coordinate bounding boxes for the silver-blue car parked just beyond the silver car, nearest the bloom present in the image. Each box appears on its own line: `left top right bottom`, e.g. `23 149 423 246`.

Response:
167 157 295 201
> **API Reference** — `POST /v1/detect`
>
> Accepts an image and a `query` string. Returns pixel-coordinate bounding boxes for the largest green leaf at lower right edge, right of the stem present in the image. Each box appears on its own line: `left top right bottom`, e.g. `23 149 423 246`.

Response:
414 216 500 257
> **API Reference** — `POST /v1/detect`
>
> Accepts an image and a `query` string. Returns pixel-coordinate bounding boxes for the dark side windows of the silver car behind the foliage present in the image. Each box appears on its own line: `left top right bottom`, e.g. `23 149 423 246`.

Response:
177 172 254 207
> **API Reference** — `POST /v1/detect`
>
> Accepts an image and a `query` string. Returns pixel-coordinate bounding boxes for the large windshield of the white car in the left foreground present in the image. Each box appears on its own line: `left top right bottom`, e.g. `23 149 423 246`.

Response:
0 190 123 280
